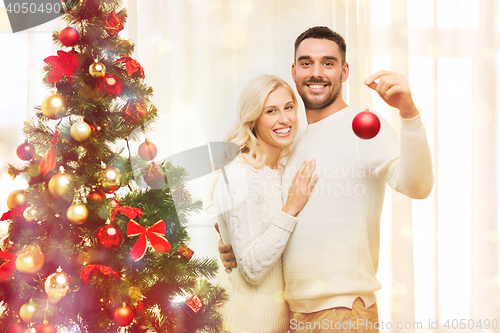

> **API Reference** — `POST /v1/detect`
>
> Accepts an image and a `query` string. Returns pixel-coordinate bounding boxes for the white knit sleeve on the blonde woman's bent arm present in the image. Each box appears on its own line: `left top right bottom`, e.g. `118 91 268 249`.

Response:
216 164 297 285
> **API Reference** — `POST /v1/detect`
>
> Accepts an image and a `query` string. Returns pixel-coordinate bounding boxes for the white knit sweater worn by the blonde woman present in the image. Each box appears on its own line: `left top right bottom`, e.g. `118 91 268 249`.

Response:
213 161 297 333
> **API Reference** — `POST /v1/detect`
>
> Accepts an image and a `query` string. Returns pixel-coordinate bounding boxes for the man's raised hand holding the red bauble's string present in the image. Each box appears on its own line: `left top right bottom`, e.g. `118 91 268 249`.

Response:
365 71 419 118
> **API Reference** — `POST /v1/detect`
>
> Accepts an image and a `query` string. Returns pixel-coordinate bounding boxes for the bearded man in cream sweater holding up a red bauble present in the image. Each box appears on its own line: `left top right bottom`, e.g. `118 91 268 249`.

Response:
219 27 434 332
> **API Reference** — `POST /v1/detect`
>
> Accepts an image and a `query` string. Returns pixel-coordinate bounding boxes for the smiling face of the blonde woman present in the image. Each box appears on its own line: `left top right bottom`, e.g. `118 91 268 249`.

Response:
255 87 297 150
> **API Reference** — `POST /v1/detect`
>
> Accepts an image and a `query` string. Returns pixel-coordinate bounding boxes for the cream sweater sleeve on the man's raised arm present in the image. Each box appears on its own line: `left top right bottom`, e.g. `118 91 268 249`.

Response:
363 111 434 199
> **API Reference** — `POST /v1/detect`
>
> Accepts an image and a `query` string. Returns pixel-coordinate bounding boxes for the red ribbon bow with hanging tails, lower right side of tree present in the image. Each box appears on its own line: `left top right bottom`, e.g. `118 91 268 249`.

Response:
127 220 171 261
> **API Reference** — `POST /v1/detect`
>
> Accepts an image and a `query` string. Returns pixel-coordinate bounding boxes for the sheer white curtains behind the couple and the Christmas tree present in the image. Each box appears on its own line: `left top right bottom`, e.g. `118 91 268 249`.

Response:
0 0 500 333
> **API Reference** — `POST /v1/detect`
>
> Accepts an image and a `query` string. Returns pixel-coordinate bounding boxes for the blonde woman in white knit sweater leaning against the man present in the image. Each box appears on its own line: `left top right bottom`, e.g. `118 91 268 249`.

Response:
213 75 317 333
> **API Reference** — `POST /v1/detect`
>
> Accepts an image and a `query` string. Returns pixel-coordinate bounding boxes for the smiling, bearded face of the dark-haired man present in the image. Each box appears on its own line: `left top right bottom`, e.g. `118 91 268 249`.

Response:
292 38 349 110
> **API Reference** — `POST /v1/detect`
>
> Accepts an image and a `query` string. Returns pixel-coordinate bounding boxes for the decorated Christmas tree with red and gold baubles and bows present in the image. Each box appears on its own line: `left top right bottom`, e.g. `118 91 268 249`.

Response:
0 0 225 333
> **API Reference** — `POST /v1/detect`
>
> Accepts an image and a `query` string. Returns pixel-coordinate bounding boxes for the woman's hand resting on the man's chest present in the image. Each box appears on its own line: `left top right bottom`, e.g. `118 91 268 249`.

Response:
282 159 318 216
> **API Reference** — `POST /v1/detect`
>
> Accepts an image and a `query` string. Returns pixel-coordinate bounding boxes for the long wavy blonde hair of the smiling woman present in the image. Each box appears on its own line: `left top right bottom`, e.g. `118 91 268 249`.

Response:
223 74 297 170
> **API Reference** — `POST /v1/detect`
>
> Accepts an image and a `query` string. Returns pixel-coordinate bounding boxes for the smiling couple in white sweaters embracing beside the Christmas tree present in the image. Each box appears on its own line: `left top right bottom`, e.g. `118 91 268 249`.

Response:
209 27 433 333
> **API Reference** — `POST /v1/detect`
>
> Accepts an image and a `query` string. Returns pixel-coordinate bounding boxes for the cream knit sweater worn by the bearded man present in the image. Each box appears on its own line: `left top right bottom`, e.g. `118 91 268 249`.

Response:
282 107 433 313
